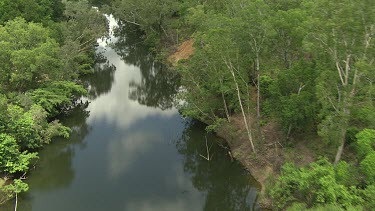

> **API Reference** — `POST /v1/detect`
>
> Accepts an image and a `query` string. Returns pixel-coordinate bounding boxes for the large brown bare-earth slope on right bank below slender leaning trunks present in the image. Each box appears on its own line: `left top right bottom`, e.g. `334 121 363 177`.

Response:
217 115 316 208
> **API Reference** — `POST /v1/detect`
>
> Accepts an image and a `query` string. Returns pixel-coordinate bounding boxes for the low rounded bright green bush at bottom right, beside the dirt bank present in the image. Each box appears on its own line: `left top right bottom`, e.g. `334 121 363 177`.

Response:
271 159 360 208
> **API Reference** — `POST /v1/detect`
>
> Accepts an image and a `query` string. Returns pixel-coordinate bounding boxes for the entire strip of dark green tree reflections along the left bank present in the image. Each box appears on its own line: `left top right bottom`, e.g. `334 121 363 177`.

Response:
0 53 116 211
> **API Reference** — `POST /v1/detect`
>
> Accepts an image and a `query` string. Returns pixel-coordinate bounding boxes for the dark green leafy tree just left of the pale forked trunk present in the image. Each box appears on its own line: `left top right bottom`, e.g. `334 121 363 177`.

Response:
263 60 319 133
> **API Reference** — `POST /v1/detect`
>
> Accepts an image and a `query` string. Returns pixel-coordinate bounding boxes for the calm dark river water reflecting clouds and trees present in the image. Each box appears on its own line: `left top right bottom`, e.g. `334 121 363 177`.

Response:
3 16 257 211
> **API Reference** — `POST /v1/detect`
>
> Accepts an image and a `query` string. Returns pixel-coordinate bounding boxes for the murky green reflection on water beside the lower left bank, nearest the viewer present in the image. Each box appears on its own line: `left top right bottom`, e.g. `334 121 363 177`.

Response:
0 106 90 211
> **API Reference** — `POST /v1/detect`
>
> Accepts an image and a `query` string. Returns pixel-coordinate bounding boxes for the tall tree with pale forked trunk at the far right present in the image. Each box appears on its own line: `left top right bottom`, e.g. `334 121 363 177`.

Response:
306 0 375 164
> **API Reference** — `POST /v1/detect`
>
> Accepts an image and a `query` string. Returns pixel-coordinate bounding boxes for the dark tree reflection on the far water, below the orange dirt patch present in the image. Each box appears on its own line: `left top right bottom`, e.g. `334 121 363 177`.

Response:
114 25 180 110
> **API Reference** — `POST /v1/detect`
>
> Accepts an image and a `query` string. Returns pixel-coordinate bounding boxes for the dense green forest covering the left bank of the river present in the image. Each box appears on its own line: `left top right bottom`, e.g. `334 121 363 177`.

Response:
0 0 107 204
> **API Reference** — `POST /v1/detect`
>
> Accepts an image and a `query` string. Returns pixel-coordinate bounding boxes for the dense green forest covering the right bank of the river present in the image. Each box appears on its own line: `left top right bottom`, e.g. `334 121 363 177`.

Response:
112 0 375 210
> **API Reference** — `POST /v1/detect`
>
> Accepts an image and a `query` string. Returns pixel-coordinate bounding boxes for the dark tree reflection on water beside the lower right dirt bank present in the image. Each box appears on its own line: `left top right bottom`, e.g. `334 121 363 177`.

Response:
176 121 257 210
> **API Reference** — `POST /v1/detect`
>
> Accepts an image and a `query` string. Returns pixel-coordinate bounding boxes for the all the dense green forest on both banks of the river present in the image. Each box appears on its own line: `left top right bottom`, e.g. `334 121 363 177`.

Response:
0 0 375 210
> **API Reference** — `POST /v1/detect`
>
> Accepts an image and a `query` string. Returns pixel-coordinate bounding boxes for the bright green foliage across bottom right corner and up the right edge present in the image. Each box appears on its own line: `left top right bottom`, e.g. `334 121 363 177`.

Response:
271 129 375 210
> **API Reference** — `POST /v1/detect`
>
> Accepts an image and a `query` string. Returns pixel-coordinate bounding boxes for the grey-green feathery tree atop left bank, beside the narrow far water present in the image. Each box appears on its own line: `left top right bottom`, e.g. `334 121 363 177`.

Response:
59 0 108 77
